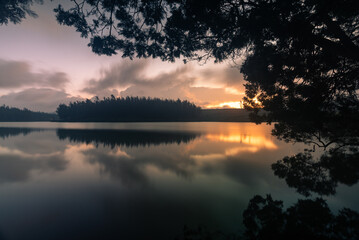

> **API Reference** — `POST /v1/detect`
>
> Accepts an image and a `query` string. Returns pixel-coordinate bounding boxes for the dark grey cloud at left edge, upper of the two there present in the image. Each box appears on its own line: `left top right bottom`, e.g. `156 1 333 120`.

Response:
0 59 69 89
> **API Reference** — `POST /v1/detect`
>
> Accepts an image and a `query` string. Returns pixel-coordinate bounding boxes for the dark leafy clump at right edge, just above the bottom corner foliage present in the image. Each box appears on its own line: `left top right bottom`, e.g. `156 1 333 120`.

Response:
272 150 359 196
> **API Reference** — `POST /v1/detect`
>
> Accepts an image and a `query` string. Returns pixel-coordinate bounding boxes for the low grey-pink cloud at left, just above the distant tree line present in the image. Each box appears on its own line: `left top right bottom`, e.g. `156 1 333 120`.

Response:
0 88 82 112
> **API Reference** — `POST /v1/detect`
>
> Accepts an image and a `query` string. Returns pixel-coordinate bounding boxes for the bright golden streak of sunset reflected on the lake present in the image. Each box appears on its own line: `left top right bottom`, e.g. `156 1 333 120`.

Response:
206 134 278 149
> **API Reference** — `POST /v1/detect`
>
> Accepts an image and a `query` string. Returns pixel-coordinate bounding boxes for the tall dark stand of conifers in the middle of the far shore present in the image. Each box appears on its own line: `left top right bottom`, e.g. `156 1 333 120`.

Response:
56 95 201 122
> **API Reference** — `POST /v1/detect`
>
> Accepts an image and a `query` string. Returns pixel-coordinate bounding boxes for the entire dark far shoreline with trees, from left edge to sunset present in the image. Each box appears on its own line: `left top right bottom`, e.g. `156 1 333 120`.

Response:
0 96 250 122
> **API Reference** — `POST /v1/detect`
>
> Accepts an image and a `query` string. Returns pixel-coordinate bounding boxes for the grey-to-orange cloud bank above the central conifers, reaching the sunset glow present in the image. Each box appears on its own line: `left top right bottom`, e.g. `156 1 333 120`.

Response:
82 60 243 106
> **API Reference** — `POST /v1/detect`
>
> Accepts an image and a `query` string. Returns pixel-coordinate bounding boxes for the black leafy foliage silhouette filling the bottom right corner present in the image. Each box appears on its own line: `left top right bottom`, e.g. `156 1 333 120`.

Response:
243 195 359 240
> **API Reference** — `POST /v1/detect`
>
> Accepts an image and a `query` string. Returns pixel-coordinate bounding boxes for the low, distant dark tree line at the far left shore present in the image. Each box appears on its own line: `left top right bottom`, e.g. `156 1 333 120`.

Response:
0 105 57 122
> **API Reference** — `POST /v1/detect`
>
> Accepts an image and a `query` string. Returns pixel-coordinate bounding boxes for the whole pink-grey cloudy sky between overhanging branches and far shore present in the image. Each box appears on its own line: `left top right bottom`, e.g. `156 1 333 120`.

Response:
0 1 244 112
